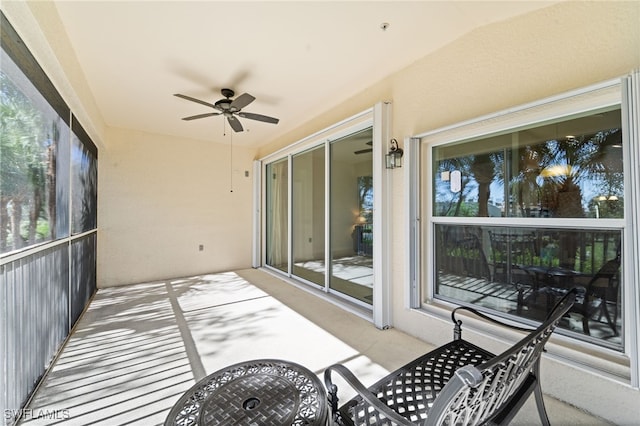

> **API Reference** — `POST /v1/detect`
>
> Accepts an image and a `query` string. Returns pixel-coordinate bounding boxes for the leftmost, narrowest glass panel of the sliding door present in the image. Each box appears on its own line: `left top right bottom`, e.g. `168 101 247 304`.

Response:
266 158 289 272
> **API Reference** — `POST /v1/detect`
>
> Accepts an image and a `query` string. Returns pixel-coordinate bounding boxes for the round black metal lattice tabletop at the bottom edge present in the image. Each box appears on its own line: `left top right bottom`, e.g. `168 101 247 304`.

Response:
164 359 327 426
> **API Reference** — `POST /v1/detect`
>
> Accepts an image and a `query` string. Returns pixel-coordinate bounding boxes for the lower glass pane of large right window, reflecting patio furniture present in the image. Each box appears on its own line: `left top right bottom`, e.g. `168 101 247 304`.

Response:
434 224 623 350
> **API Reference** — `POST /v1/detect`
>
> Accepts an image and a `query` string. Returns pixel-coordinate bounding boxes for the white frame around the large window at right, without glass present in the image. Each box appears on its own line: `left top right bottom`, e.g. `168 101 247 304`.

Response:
405 75 640 388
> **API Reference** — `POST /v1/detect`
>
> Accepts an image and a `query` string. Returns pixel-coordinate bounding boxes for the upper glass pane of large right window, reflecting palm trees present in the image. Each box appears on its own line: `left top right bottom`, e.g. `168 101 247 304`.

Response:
433 109 624 218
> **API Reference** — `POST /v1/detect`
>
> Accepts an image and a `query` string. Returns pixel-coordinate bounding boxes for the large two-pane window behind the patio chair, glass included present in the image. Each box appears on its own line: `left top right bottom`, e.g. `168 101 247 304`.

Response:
422 84 625 351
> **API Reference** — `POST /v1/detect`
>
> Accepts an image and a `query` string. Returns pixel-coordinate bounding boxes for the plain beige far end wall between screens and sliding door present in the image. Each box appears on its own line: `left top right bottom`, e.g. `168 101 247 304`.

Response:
98 128 254 286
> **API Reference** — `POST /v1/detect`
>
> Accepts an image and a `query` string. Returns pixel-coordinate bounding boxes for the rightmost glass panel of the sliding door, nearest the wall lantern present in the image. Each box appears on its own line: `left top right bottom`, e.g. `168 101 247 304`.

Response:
329 128 373 304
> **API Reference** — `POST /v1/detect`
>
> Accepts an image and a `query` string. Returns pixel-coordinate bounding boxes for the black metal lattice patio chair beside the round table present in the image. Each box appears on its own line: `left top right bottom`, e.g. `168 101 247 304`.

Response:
324 289 577 426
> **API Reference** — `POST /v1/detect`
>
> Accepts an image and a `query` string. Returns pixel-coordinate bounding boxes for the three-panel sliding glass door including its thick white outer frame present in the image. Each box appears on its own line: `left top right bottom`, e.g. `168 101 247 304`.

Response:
262 102 394 328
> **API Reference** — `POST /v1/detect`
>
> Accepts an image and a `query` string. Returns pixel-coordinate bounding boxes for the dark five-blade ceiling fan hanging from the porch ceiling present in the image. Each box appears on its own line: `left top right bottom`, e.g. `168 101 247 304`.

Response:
174 89 280 132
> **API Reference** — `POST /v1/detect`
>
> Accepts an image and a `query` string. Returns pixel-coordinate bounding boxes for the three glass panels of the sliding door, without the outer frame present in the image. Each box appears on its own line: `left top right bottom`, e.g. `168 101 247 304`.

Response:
264 126 374 306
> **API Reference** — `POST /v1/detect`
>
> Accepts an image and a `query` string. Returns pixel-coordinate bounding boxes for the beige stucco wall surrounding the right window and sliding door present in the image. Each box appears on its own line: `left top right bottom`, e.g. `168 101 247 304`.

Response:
259 2 640 425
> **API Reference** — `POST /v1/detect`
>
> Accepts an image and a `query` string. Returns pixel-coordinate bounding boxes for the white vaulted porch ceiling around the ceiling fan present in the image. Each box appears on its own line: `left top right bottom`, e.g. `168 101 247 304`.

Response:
55 1 552 146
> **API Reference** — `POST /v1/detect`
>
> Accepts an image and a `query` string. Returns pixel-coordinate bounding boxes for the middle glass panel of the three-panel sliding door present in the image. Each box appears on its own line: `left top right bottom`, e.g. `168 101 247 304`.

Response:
291 146 326 287
